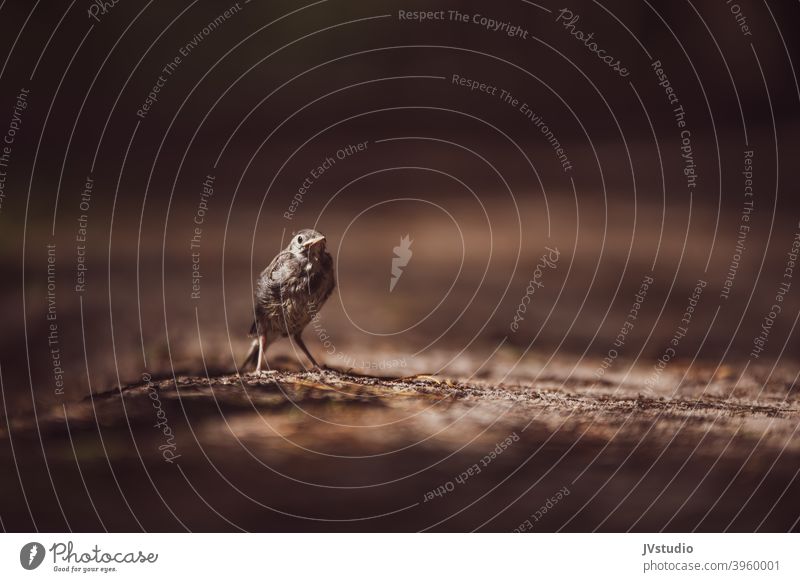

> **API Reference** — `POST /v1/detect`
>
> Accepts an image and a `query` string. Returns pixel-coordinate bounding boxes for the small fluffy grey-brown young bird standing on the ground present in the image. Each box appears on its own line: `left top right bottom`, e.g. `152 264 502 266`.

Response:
242 229 336 373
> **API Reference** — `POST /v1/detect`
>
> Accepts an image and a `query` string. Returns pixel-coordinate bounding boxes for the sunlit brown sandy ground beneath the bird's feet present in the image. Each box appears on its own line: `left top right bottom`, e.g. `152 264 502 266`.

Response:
2 356 800 531
